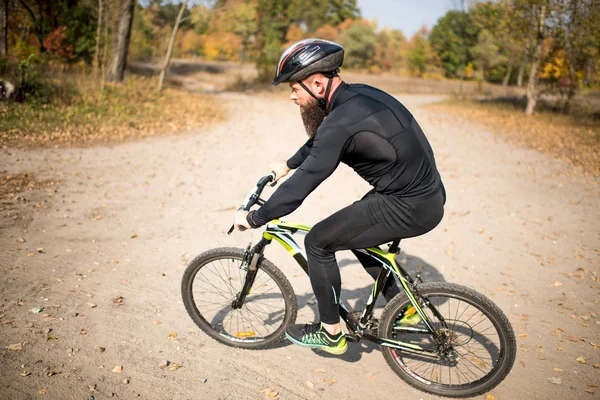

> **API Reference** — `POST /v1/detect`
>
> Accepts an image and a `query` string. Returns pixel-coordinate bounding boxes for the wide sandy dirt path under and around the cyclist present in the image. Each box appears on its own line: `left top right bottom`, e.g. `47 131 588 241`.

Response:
0 94 600 399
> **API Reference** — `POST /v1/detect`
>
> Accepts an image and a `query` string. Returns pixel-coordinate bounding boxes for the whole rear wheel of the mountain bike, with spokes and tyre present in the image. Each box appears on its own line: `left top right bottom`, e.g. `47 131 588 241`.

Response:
379 282 517 397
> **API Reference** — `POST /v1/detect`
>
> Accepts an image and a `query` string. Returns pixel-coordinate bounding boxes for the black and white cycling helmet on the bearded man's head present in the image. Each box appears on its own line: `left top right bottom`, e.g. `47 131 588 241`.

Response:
273 39 344 86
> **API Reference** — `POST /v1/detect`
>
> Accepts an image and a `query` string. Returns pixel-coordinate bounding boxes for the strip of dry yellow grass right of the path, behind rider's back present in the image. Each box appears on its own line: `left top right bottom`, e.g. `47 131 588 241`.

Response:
428 100 600 176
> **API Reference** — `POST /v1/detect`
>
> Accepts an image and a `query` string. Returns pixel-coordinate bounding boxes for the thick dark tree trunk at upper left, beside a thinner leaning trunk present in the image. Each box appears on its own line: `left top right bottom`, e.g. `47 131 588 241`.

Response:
108 0 136 82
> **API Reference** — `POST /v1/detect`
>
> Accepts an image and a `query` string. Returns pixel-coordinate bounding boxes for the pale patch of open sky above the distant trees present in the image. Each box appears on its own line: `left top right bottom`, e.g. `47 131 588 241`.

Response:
357 0 459 39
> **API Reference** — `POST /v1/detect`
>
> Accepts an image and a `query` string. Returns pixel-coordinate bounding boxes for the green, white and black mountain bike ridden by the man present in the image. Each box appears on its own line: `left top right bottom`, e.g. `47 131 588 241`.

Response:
181 174 516 397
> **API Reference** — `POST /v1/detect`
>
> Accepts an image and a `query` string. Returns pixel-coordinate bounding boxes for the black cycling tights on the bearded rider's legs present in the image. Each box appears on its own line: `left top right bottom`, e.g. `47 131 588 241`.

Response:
304 186 446 324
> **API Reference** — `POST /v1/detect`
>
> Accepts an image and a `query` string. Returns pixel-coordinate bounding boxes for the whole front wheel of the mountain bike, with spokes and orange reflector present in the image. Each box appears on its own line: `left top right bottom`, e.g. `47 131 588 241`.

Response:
181 248 298 349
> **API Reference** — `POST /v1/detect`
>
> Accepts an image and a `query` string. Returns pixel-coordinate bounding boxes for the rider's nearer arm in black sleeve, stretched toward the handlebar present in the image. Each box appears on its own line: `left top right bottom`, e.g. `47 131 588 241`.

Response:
248 127 348 228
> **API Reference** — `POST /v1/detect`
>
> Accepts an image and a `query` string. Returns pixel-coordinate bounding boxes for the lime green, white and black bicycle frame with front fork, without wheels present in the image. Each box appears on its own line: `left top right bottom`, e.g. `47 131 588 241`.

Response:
241 220 444 354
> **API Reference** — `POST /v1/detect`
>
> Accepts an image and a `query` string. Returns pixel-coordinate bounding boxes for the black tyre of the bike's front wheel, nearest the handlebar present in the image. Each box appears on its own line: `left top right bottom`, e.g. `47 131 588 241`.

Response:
181 247 298 350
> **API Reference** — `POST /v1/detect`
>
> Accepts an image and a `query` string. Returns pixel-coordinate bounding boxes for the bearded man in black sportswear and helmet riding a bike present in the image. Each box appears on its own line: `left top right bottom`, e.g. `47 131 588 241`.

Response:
234 39 446 354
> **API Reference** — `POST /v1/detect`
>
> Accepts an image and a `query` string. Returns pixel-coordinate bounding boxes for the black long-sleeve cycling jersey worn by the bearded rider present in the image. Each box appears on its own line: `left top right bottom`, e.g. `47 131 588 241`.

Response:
250 83 442 226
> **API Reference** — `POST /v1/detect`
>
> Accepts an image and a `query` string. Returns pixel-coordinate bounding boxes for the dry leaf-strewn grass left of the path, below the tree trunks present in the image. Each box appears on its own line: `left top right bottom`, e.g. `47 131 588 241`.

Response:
0 74 222 147
